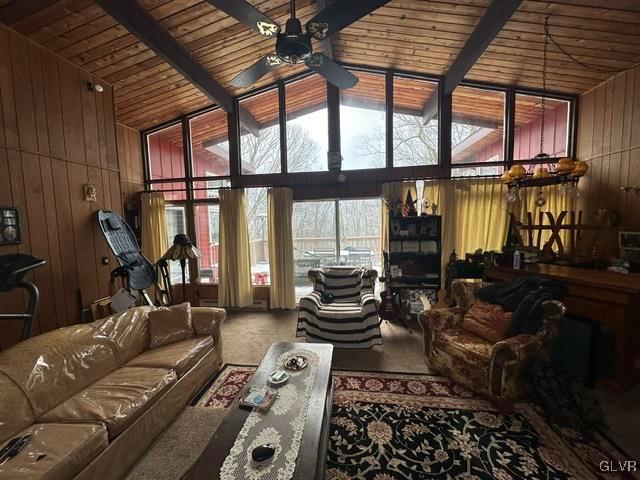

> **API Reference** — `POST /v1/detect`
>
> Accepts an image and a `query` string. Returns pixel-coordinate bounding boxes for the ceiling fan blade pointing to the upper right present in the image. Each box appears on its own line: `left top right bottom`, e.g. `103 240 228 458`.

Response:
306 0 390 40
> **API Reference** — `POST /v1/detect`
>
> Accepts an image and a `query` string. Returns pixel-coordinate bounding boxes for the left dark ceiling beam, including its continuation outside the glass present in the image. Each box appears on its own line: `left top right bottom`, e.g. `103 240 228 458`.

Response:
96 0 260 136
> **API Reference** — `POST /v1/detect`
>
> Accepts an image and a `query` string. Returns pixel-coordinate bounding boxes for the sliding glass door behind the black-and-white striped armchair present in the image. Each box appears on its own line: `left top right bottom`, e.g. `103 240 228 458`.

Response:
292 198 382 298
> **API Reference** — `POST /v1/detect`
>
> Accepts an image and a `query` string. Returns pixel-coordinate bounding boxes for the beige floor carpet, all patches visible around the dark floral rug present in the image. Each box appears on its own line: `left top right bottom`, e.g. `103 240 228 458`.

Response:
127 311 640 480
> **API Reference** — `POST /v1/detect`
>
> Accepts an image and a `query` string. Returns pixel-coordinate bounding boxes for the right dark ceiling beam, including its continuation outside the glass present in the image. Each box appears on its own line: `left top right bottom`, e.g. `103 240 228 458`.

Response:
422 0 522 124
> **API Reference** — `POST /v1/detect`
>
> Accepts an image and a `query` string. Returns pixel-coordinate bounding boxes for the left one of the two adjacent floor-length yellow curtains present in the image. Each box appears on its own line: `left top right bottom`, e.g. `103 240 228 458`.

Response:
218 190 253 307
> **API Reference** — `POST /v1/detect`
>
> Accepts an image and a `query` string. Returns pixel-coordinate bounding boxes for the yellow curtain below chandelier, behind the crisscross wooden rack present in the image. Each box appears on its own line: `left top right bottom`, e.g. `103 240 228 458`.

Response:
514 185 577 253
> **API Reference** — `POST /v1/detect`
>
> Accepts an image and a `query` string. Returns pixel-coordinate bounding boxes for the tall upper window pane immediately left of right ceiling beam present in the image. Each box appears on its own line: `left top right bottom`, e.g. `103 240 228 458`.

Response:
393 77 438 167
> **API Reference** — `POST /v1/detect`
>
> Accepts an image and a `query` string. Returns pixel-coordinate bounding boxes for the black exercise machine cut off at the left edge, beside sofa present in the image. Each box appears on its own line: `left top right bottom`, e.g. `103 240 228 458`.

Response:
0 253 47 340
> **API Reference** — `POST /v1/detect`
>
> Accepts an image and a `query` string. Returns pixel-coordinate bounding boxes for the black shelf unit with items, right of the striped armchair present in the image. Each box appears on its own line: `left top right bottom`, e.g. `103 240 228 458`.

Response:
389 215 442 317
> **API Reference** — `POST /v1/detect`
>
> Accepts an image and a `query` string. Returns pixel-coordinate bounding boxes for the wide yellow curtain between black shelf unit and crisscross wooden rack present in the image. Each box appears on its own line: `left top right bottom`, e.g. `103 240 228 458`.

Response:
439 178 508 261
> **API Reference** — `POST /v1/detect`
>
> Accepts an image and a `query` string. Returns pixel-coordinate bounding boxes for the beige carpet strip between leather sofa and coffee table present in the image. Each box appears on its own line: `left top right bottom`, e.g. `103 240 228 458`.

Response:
126 407 227 480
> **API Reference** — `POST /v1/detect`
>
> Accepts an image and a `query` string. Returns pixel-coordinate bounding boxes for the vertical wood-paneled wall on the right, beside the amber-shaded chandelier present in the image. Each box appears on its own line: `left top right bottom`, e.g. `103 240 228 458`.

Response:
578 67 640 256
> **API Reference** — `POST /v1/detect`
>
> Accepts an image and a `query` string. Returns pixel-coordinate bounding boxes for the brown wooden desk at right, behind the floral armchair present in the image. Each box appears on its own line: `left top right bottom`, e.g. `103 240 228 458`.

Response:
485 265 640 391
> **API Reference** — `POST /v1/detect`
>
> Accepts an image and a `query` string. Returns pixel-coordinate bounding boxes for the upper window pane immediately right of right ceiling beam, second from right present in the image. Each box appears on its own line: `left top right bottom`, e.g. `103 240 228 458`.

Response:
451 87 505 164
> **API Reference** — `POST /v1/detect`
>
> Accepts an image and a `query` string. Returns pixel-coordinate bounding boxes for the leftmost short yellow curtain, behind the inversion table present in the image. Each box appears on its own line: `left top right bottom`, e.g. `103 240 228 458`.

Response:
140 192 169 263
